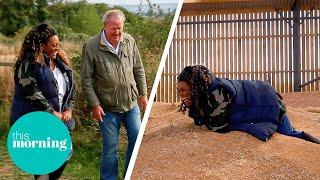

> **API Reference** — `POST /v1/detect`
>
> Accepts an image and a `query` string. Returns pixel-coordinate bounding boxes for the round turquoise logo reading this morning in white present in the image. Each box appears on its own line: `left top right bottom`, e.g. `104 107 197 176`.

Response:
7 112 72 175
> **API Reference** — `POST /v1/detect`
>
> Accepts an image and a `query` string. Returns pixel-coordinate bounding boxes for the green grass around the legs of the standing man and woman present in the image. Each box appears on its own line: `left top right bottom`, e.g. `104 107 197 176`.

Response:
0 101 127 180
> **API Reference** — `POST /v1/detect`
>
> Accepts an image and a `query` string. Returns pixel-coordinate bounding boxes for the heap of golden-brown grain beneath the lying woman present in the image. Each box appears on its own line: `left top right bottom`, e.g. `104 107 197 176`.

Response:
131 91 320 179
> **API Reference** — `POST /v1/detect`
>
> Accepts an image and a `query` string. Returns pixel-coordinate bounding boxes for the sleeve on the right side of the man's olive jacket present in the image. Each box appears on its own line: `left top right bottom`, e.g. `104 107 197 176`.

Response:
133 40 148 96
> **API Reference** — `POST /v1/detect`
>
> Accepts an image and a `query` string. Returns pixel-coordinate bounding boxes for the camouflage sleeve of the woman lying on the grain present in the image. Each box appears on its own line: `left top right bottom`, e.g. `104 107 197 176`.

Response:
205 87 232 131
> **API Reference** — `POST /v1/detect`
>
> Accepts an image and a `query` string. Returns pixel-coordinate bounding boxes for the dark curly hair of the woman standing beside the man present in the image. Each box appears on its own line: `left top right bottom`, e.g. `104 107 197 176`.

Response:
18 24 57 62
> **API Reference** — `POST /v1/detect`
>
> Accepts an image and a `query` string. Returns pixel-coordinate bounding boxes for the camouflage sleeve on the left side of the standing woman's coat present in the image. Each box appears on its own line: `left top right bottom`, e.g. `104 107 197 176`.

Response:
17 62 54 112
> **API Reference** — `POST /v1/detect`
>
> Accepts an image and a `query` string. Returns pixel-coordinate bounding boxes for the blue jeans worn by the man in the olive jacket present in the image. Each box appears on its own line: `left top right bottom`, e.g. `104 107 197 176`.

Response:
99 105 141 180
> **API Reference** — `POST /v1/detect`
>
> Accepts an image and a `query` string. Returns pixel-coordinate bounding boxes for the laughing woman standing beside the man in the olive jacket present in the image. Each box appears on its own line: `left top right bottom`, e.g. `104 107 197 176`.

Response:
10 24 75 179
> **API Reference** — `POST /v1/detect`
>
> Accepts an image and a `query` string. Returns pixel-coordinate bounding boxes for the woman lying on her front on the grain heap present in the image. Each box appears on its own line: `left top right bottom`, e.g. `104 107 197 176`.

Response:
177 65 320 144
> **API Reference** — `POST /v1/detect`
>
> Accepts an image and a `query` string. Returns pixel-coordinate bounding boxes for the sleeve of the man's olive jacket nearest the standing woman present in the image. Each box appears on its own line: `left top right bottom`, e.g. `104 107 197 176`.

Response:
80 44 100 108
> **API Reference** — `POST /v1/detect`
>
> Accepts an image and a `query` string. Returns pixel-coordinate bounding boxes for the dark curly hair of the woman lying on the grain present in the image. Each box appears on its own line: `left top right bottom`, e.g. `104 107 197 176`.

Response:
177 65 211 112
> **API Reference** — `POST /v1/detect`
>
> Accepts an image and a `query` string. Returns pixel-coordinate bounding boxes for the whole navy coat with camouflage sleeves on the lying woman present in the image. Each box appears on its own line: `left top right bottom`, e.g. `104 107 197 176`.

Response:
189 77 285 141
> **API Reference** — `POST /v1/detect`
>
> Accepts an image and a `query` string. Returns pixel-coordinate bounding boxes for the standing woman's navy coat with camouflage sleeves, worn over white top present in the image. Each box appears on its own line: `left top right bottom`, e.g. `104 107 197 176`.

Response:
10 55 75 129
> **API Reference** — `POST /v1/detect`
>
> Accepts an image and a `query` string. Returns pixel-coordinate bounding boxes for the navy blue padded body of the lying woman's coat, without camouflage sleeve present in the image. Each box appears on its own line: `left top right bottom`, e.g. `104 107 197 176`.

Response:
209 77 280 141
